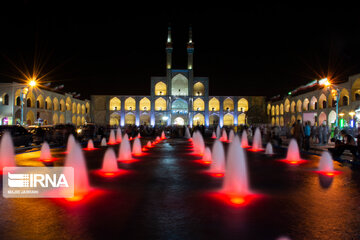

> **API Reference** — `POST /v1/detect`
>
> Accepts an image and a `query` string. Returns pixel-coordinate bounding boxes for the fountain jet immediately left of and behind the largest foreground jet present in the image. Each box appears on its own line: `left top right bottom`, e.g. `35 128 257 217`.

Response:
208 140 225 177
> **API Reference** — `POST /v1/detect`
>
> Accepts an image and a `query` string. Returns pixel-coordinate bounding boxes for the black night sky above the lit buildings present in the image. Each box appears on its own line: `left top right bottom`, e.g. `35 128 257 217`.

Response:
0 1 360 97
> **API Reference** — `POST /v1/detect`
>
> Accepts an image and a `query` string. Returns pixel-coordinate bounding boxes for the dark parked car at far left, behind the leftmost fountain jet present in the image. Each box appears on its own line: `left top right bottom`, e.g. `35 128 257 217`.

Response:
0 125 32 147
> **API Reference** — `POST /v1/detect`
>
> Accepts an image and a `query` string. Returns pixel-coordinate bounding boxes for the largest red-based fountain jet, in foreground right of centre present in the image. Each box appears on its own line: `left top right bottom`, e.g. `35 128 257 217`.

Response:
222 136 252 204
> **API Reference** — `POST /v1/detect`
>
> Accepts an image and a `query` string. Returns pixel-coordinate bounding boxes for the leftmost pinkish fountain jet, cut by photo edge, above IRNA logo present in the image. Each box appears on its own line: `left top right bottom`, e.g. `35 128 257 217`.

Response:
0 132 16 173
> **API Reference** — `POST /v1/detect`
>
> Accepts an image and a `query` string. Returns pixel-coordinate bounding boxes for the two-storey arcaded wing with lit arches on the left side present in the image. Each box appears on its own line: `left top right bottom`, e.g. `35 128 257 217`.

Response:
0 82 91 126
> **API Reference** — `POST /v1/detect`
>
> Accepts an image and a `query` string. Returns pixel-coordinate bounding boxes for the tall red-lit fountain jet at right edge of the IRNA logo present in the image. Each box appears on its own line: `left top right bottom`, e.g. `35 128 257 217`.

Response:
65 143 90 200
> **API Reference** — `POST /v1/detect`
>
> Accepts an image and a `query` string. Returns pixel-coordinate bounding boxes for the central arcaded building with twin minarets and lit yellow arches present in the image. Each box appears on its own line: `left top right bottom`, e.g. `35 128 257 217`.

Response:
91 27 266 126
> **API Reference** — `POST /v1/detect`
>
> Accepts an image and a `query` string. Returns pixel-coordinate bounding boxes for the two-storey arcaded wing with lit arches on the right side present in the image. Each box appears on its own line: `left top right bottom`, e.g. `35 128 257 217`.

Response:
267 74 360 127
